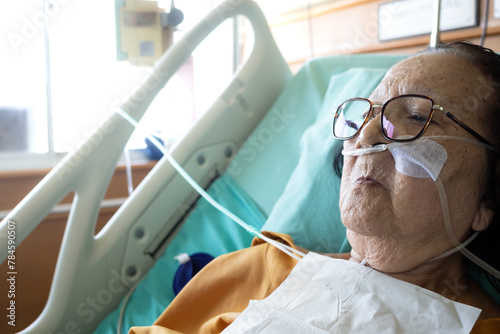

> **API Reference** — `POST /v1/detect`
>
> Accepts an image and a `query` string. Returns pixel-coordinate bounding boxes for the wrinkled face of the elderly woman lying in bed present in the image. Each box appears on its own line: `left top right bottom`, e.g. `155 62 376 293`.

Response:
340 54 490 273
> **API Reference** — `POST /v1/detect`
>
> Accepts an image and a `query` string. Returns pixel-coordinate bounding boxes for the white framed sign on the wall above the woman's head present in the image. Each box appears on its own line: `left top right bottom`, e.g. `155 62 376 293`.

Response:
378 0 480 41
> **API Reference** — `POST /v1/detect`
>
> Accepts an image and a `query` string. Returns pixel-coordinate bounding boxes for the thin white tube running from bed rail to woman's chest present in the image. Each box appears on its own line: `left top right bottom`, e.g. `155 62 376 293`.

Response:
115 109 305 260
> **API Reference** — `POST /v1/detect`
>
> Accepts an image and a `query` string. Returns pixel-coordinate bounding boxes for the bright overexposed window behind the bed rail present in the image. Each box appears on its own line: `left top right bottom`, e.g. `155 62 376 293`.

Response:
0 0 238 170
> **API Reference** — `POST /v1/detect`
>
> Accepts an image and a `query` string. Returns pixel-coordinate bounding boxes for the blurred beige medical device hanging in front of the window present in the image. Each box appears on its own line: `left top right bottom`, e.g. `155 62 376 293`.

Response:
115 0 184 66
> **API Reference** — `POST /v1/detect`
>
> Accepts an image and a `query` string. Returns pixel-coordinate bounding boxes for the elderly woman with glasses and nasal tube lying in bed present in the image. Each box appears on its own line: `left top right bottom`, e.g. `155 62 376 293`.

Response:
130 43 500 333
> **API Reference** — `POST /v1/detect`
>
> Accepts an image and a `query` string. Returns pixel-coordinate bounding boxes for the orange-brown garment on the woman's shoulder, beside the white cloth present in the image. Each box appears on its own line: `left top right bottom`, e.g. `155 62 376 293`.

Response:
130 233 500 334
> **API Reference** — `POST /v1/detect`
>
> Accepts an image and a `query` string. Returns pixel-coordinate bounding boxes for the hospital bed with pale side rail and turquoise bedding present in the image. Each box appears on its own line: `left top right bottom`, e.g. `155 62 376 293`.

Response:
0 0 498 333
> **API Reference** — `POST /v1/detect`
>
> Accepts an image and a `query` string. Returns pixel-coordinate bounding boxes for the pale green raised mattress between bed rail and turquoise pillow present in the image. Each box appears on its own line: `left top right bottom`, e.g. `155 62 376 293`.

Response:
230 54 406 216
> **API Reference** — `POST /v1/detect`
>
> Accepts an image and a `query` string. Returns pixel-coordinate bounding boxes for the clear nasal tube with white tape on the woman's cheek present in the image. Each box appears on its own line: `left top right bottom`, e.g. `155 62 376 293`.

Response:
342 136 500 279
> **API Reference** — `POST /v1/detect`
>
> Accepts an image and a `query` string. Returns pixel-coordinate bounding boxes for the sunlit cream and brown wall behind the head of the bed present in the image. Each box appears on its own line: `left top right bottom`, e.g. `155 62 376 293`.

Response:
269 0 500 69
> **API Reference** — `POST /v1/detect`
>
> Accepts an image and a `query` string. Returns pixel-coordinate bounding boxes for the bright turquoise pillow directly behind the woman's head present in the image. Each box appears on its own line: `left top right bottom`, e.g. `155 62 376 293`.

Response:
262 68 387 252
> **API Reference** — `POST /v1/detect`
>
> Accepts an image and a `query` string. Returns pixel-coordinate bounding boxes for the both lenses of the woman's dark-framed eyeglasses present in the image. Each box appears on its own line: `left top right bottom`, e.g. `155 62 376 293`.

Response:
334 96 432 140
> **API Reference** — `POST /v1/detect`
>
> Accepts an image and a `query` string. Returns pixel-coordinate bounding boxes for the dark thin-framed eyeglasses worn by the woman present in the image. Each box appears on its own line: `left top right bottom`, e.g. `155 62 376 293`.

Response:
333 94 491 145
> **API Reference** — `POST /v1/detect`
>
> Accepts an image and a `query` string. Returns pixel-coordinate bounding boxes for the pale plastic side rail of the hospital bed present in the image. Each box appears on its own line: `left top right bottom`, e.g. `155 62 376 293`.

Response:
0 0 291 333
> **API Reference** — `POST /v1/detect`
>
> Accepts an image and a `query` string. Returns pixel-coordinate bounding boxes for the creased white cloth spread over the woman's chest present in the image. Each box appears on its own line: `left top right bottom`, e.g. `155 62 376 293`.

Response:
223 253 481 334
